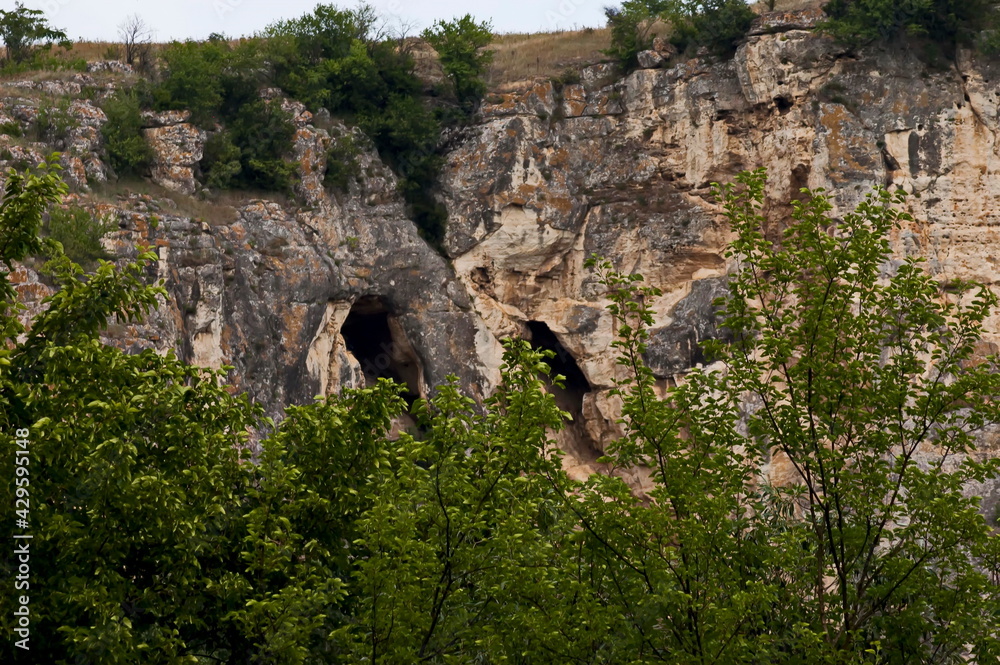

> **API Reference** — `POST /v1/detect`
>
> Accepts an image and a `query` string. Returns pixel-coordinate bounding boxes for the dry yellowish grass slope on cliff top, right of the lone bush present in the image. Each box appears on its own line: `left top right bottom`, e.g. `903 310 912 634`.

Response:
487 28 611 90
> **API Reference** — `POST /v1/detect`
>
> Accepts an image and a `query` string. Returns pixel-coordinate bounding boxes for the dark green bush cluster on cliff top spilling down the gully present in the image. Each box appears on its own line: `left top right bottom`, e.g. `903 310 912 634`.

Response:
152 4 460 244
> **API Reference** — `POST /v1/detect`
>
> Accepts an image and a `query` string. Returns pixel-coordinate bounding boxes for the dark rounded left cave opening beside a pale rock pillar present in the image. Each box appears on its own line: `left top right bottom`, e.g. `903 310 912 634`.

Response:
340 296 424 407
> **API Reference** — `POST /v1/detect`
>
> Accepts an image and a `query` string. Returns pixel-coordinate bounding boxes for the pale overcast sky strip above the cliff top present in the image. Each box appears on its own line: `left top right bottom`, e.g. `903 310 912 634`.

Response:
17 0 618 41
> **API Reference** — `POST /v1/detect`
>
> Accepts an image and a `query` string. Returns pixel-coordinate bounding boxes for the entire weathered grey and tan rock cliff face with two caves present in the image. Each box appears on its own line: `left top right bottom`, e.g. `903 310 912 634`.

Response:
0 13 1000 514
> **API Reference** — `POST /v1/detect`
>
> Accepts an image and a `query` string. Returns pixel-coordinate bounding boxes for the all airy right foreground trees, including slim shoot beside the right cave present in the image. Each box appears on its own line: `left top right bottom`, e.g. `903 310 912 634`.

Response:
581 171 1000 663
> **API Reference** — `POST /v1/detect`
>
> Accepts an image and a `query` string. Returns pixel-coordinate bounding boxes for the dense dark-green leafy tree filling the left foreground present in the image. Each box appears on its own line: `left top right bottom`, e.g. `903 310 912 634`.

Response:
0 160 402 663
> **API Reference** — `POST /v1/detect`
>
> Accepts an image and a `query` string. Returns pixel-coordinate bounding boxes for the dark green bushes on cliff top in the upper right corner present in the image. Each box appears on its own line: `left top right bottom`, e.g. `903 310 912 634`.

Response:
824 0 1000 48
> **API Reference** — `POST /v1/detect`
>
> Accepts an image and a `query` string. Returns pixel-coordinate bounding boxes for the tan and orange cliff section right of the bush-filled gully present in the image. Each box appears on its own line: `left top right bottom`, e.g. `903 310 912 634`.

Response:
443 11 1000 513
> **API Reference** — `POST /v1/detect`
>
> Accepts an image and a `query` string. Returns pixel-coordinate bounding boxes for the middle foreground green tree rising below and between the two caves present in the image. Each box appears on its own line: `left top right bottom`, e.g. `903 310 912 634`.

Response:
352 342 572 663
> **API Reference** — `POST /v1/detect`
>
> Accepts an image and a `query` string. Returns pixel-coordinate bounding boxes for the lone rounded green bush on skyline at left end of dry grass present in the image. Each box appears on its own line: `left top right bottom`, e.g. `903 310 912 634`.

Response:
421 14 493 111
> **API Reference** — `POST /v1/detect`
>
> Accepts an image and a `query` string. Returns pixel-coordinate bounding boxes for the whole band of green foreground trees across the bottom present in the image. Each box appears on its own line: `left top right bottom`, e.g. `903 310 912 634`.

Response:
0 163 1000 665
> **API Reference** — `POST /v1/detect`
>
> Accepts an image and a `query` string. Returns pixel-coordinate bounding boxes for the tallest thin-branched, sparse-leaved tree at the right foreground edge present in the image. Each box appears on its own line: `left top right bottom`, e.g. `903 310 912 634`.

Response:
711 172 1000 663
